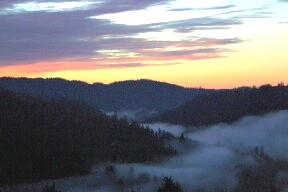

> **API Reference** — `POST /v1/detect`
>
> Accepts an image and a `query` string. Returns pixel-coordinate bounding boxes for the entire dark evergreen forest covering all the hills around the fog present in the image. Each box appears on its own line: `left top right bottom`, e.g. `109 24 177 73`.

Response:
0 78 288 192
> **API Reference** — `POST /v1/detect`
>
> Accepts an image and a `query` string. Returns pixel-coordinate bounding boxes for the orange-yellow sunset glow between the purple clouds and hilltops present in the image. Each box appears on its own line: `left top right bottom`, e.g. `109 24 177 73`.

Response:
0 20 288 88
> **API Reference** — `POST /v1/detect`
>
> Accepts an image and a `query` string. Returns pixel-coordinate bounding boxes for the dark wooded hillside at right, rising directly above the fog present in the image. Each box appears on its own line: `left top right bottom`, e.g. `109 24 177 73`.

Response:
153 85 288 126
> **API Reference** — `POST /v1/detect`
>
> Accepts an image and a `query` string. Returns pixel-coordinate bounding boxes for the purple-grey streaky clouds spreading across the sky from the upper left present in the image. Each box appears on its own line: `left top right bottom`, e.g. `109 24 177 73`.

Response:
0 0 241 70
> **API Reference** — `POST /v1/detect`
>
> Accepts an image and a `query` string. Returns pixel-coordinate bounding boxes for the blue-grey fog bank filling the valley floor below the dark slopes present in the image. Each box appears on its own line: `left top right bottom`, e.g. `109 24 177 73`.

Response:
9 111 288 192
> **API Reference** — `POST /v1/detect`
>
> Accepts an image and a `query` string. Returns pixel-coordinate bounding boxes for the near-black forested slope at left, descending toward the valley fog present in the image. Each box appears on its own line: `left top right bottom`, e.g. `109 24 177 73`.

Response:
0 89 175 184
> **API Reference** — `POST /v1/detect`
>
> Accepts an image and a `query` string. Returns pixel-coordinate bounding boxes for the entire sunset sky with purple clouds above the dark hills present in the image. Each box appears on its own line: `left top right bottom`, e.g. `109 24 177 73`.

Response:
0 0 288 88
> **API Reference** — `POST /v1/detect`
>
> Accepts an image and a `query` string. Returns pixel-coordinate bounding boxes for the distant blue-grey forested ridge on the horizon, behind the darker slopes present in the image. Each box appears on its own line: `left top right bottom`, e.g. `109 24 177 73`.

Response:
0 78 213 112
